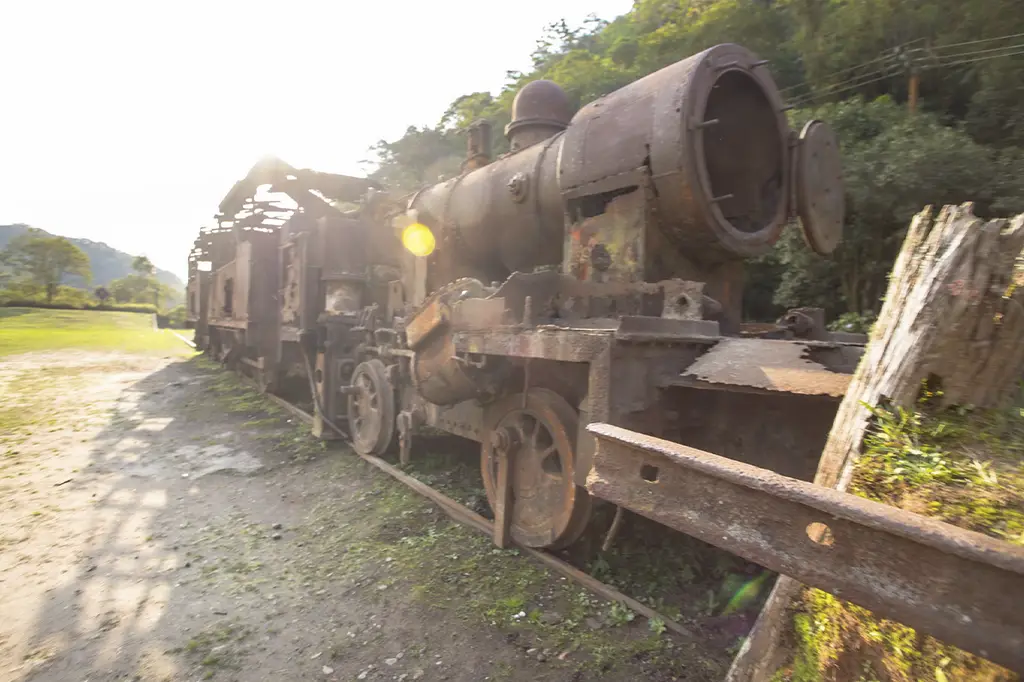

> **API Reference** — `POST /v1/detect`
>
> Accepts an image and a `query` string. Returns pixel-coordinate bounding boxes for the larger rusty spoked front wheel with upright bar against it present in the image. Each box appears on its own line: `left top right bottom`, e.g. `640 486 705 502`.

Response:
480 388 591 550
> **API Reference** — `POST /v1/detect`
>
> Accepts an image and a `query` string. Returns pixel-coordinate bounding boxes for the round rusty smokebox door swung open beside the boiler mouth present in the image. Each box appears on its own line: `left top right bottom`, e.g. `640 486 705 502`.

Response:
790 120 845 256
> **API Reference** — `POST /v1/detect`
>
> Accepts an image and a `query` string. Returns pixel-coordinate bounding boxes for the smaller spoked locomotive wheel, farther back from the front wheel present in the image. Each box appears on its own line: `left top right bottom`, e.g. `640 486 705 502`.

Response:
348 359 394 455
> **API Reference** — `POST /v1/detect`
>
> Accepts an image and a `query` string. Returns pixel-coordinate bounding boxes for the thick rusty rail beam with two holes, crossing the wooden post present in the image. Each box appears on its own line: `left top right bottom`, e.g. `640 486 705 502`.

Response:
587 423 1024 672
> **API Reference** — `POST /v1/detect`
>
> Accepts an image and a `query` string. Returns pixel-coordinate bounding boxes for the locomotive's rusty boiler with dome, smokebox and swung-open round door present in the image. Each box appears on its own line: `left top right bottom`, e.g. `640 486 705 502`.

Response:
399 45 843 307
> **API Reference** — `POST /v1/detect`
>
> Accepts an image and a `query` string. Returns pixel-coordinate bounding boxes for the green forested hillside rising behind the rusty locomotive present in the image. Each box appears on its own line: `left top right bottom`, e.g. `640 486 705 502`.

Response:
374 0 1024 324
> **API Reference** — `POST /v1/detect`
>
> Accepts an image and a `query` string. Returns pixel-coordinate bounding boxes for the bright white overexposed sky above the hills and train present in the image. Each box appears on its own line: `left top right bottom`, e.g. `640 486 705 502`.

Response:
0 0 632 276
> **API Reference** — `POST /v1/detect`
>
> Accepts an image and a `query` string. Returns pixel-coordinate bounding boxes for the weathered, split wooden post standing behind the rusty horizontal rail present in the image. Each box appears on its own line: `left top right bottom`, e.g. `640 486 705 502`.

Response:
727 204 1024 682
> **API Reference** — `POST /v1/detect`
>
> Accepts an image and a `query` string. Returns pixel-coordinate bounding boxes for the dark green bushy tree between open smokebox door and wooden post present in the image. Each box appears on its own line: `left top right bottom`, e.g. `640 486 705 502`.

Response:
775 97 1013 313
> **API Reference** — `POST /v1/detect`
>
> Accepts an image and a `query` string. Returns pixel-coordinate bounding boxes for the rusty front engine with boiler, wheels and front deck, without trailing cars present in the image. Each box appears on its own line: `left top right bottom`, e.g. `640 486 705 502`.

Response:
316 44 864 548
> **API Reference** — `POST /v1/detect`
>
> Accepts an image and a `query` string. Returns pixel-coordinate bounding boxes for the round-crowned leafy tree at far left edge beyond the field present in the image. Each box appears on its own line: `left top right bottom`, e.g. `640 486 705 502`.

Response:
0 228 92 303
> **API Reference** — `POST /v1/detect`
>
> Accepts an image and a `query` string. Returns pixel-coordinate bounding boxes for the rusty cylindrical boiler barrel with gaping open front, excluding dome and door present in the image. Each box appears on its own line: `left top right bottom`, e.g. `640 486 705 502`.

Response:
410 44 791 271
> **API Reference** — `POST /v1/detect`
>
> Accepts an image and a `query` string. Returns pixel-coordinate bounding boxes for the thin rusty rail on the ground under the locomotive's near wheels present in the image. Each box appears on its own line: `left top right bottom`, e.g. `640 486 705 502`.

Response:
260 375 695 639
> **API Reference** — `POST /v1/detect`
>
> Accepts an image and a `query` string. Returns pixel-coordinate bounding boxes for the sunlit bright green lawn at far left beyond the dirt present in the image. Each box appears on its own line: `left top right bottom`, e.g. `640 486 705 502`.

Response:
0 308 193 356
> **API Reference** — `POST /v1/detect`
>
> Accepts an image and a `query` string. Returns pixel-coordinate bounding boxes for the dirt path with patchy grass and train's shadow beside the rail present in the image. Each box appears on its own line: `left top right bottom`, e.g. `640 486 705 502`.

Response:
0 352 721 681
